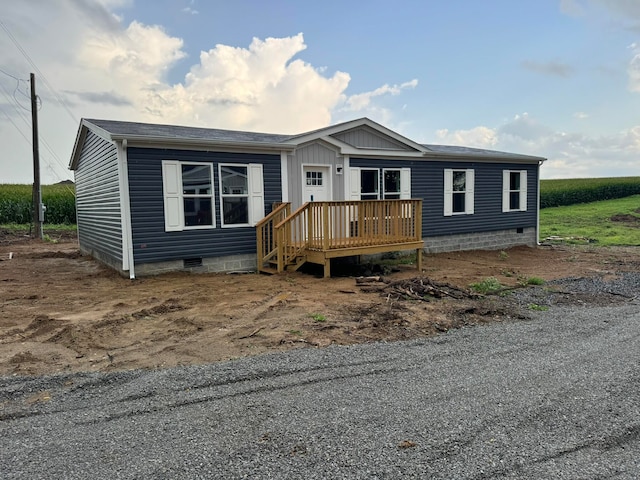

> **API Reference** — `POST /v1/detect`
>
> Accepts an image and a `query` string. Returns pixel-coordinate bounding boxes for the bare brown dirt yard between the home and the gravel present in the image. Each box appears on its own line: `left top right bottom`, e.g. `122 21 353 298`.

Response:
0 232 640 375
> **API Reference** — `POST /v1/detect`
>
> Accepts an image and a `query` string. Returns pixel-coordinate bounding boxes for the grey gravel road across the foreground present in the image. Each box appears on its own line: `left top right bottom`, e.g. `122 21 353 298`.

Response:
0 286 640 479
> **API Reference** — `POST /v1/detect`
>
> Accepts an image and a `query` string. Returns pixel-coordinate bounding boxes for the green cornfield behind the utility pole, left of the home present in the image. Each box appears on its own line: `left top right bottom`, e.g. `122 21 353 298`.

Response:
0 184 76 225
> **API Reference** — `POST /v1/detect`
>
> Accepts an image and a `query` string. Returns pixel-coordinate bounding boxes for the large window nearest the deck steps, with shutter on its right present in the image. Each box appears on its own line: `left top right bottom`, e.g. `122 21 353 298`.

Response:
218 163 264 227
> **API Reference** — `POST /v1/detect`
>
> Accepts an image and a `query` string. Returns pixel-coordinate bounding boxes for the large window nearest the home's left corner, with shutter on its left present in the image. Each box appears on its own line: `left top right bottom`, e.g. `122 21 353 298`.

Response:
162 160 215 232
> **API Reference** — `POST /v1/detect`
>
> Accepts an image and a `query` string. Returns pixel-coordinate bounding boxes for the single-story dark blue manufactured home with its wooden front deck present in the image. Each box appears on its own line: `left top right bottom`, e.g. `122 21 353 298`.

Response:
69 118 545 278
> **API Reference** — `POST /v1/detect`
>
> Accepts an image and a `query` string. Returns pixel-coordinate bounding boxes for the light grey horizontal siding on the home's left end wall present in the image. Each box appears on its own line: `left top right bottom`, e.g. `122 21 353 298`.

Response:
74 131 123 271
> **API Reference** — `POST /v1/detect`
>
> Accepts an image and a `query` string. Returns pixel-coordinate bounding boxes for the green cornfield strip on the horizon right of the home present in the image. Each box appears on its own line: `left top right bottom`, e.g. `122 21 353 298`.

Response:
540 177 640 208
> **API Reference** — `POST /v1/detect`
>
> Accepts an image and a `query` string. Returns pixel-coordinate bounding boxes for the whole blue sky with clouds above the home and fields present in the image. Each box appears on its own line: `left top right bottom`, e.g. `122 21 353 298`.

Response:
0 0 640 184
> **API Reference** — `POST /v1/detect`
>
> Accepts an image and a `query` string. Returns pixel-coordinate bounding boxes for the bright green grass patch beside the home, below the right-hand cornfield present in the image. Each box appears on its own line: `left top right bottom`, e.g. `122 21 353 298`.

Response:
540 195 640 246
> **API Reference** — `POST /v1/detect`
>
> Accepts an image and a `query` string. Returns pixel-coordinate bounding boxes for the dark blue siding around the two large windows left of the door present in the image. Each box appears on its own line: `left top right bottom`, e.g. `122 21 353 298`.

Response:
127 148 282 264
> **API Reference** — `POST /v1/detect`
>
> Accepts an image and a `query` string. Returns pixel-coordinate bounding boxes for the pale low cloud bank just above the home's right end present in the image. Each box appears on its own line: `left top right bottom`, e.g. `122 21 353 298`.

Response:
434 113 640 178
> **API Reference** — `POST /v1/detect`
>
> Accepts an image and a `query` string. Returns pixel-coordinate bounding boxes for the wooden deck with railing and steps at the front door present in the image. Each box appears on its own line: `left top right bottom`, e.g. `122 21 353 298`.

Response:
256 200 424 277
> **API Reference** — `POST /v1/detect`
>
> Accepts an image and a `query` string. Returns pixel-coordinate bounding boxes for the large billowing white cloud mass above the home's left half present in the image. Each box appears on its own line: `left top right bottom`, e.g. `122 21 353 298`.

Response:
0 0 417 183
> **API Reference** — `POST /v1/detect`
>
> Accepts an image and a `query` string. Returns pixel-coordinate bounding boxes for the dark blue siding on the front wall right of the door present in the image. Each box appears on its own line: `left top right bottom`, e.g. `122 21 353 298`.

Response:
350 158 538 237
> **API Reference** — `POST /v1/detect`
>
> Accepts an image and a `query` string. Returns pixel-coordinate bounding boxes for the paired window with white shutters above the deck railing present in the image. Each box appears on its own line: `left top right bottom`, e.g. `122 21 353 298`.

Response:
349 167 411 200
